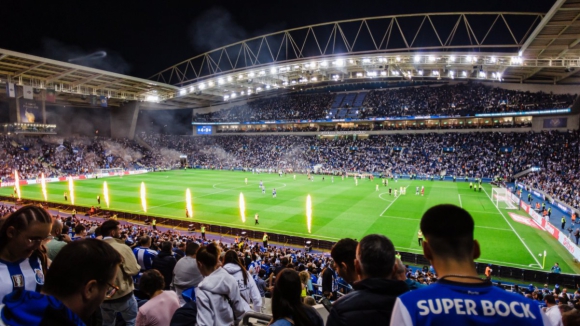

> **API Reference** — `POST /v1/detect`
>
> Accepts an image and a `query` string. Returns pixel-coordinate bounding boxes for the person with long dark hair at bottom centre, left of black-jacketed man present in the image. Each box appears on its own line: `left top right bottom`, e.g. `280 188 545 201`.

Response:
270 268 324 326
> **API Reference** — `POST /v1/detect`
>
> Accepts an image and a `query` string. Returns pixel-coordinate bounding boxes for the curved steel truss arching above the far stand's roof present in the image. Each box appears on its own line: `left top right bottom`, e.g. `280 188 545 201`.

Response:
150 12 544 86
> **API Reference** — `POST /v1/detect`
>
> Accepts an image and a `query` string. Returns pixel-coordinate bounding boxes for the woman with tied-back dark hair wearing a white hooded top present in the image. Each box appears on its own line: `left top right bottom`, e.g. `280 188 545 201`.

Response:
195 243 251 326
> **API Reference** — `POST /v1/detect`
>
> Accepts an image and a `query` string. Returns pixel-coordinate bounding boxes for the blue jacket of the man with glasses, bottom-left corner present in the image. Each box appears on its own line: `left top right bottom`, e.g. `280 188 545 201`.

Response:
1 290 85 326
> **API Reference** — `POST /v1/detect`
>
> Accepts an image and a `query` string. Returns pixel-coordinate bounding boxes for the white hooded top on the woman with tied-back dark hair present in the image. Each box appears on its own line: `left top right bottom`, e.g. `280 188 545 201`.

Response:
195 267 251 326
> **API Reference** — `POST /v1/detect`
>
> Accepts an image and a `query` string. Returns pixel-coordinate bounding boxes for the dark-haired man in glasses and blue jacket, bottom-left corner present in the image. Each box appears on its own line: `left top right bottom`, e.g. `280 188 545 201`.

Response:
1 239 122 326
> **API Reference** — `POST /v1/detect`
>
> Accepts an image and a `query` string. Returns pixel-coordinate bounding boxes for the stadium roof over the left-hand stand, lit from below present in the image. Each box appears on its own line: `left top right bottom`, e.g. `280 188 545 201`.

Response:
0 49 178 106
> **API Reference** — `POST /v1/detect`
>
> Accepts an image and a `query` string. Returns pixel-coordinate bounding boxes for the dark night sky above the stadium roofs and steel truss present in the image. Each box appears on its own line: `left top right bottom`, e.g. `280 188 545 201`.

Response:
0 0 555 78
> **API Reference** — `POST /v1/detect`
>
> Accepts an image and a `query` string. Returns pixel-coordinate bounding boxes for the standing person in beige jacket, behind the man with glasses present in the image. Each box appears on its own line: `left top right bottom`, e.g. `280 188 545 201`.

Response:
101 220 141 326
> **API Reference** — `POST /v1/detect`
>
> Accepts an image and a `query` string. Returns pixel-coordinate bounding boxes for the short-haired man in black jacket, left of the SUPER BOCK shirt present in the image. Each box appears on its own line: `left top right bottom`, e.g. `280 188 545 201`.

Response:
326 234 408 326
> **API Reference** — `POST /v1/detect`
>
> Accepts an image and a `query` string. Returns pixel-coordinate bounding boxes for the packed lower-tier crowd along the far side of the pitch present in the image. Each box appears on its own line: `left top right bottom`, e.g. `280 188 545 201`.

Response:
0 131 580 208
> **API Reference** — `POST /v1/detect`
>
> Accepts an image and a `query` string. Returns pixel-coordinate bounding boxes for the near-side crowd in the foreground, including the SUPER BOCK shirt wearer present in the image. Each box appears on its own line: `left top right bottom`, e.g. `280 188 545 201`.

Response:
0 204 580 326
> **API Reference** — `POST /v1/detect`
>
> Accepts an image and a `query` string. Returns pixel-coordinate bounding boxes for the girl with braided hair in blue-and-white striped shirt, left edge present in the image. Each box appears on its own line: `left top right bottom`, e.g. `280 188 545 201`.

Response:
0 205 52 300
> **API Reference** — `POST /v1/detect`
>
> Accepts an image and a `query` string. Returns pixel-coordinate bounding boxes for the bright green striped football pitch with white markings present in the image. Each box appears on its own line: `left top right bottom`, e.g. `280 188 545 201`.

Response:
0 170 580 273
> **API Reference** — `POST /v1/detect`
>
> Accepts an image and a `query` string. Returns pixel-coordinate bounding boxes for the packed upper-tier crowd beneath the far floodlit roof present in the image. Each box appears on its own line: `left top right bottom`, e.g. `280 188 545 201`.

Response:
193 83 577 122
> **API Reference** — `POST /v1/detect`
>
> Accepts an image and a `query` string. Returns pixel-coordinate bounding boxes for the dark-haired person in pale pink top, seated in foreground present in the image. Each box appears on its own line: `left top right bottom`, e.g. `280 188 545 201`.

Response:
136 269 179 326
